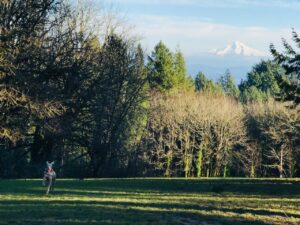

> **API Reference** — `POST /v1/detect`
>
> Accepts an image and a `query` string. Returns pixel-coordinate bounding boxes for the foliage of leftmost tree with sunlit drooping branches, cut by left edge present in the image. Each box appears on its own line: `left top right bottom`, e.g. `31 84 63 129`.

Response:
0 0 66 142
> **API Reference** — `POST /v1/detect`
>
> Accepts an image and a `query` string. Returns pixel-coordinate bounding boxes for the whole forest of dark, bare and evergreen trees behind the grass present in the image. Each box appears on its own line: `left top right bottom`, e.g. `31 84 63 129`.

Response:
0 0 300 178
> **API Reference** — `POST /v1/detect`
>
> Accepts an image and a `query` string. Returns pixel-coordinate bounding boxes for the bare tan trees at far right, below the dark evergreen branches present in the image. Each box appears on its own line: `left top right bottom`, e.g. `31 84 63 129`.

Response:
247 101 300 177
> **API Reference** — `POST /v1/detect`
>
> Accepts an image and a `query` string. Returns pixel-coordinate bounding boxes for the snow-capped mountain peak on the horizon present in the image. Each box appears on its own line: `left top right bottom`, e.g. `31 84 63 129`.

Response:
209 41 267 57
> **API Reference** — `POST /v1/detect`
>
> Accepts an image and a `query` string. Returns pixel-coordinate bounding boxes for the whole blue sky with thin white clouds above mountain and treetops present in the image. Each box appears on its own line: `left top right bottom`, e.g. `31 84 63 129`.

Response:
96 0 300 79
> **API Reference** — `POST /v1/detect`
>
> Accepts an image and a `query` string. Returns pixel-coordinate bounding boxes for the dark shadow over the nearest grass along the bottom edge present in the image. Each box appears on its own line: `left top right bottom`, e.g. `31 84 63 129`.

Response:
0 201 274 225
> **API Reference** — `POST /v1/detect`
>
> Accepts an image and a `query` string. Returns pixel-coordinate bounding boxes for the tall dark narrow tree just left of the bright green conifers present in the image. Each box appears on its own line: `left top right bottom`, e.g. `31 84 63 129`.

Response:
87 35 146 176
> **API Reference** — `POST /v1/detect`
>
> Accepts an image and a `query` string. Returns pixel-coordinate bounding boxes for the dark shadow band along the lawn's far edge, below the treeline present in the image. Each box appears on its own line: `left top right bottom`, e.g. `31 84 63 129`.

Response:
0 179 300 198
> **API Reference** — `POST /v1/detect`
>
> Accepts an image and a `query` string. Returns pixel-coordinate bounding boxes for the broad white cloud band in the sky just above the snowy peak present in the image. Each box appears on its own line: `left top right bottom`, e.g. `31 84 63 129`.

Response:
131 14 291 56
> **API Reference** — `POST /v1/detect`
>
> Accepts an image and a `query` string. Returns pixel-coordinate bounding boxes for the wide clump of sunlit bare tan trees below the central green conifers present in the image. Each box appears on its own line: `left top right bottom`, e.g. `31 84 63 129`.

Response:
141 92 245 177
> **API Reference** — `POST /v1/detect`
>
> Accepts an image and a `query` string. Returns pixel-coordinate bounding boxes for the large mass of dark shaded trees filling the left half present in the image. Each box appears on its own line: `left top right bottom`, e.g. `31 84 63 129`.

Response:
0 0 147 177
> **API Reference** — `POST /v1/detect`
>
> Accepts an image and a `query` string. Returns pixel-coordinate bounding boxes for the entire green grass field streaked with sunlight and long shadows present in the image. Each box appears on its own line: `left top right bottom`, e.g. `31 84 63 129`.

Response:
0 179 300 225
